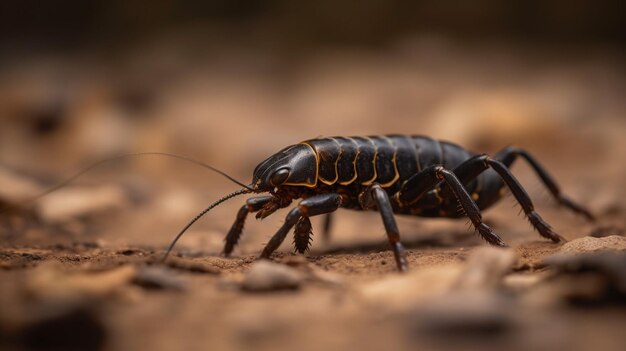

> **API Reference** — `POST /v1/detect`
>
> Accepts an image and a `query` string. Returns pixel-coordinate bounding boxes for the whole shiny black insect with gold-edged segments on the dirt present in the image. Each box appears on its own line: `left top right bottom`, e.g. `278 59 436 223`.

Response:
163 135 593 271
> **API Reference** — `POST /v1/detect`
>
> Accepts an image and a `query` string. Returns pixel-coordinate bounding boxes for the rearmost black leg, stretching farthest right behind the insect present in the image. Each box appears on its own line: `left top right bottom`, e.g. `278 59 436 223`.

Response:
494 147 595 221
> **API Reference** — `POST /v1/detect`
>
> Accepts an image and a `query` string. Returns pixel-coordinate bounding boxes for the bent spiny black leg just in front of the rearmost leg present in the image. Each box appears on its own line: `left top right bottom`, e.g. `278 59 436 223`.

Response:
454 155 567 243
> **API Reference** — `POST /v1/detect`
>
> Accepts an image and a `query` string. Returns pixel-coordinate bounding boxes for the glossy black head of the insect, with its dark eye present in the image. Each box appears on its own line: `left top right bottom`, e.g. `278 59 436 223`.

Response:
252 143 317 192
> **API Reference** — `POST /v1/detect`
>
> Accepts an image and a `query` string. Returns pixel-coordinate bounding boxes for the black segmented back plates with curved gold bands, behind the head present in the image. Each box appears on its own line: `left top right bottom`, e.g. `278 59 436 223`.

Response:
304 135 471 188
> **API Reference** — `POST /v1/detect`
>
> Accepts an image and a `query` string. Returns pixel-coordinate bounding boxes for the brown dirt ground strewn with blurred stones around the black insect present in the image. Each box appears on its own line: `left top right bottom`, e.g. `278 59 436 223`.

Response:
0 38 626 350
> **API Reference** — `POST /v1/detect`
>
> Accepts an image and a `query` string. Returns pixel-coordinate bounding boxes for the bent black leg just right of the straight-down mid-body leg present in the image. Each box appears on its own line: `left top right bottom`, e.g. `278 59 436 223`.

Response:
394 165 506 246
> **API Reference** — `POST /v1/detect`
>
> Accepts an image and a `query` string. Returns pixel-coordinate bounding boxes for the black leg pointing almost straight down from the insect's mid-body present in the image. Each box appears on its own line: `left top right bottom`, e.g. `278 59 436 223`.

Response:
359 184 408 272
